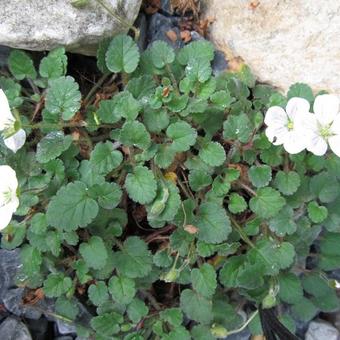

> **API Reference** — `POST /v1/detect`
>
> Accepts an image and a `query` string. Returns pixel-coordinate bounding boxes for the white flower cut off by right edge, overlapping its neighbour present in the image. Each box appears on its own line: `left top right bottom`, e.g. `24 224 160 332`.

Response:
304 94 340 157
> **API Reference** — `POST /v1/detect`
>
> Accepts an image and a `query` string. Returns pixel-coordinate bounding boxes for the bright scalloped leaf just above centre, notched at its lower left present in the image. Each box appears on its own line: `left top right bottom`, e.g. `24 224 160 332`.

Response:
166 121 197 152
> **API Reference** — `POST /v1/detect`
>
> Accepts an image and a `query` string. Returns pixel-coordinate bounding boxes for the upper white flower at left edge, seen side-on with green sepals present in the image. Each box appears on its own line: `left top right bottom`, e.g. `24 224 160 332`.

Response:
0 89 26 152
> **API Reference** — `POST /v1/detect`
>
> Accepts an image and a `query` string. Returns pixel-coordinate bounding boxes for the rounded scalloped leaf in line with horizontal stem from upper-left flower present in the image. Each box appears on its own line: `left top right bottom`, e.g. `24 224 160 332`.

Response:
119 121 151 149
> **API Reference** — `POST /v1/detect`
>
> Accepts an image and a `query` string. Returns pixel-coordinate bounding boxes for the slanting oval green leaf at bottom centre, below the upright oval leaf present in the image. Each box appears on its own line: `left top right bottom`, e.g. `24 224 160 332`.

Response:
180 289 213 324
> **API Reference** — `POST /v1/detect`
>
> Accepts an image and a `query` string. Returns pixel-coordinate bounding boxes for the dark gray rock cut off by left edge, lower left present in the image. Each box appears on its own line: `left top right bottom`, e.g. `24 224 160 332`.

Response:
0 248 21 301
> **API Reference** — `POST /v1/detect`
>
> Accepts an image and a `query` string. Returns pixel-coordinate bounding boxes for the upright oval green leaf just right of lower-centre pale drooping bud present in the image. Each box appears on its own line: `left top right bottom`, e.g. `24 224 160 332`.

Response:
191 263 217 298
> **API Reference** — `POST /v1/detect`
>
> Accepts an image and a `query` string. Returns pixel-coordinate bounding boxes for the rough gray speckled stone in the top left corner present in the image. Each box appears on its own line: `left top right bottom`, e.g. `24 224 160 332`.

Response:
0 0 141 55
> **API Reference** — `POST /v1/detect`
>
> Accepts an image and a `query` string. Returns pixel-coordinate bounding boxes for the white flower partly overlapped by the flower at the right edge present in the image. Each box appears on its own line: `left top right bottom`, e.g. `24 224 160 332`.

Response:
264 97 309 154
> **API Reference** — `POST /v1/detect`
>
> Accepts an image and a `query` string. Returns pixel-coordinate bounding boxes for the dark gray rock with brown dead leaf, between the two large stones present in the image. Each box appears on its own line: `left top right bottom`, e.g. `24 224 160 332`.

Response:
148 13 184 48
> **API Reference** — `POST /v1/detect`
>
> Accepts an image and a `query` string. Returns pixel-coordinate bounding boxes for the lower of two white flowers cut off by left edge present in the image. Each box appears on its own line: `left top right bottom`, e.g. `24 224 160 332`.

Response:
0 165 19 230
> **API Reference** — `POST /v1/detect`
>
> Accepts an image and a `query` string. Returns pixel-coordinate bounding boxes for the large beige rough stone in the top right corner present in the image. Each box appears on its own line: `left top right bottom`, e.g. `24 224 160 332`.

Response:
204 0 340 92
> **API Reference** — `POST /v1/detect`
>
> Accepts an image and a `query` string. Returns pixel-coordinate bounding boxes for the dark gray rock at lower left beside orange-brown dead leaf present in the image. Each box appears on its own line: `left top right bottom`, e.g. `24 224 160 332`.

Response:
3 288 42 320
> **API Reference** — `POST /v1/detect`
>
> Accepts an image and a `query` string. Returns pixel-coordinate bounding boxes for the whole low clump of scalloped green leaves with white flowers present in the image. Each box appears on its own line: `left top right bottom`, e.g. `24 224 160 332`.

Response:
0 35 340 340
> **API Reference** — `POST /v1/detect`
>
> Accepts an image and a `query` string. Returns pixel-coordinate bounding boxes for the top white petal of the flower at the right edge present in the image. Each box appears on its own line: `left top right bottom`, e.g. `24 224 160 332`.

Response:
313 94 340 125
